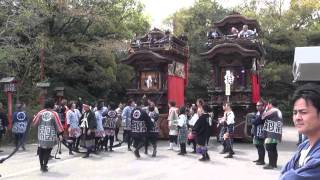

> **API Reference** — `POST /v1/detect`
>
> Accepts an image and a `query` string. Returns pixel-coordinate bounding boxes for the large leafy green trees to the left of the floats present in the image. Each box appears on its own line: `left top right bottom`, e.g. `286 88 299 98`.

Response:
0 0 150 105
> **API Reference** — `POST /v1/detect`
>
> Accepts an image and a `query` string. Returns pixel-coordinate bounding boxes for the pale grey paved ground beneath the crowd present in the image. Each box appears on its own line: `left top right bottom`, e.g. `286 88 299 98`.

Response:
0 127 297 180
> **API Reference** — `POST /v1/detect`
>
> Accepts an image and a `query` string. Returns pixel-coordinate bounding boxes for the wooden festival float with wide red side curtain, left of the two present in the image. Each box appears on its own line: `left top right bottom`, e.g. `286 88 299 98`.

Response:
121 28 189 138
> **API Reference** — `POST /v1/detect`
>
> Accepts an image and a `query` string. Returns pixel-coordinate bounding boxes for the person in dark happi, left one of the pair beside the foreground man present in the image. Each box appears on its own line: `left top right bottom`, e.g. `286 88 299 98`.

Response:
251 100 266 165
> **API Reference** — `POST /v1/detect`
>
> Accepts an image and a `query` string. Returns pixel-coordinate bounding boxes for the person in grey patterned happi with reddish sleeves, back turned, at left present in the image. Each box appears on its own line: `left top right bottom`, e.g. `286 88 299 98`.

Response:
33 99 63 172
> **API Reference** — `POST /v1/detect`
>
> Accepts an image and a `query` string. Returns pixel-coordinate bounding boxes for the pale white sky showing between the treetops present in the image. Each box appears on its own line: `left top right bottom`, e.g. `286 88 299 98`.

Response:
140 0 243 29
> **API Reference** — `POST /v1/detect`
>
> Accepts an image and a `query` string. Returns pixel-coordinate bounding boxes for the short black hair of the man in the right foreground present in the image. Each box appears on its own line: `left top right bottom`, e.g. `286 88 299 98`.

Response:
292 83 320 112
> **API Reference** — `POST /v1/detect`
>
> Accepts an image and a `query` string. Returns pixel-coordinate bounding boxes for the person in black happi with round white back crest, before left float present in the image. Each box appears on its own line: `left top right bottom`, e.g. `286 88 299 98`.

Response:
131 102 152 158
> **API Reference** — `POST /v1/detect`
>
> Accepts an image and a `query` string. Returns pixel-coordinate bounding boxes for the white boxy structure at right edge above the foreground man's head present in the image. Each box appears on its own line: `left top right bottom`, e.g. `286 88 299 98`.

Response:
292 46 320 82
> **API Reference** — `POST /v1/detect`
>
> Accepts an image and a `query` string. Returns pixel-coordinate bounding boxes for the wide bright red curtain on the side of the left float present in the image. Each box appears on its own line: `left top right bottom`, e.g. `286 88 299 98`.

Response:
168 75 185 107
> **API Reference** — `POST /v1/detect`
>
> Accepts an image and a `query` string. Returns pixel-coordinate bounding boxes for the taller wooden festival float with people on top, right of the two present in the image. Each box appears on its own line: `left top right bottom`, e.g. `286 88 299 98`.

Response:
201 14 265 138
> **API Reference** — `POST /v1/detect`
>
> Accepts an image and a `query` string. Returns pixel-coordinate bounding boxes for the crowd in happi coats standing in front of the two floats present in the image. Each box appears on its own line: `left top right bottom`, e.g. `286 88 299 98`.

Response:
0 96 282 172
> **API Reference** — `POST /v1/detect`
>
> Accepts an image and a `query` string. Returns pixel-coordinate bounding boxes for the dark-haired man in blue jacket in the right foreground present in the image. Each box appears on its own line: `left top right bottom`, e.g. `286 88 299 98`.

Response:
280 83 320 180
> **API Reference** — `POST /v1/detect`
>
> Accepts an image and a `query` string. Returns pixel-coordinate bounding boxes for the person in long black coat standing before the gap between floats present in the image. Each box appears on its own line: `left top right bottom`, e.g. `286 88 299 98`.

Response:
192 105 210 161
